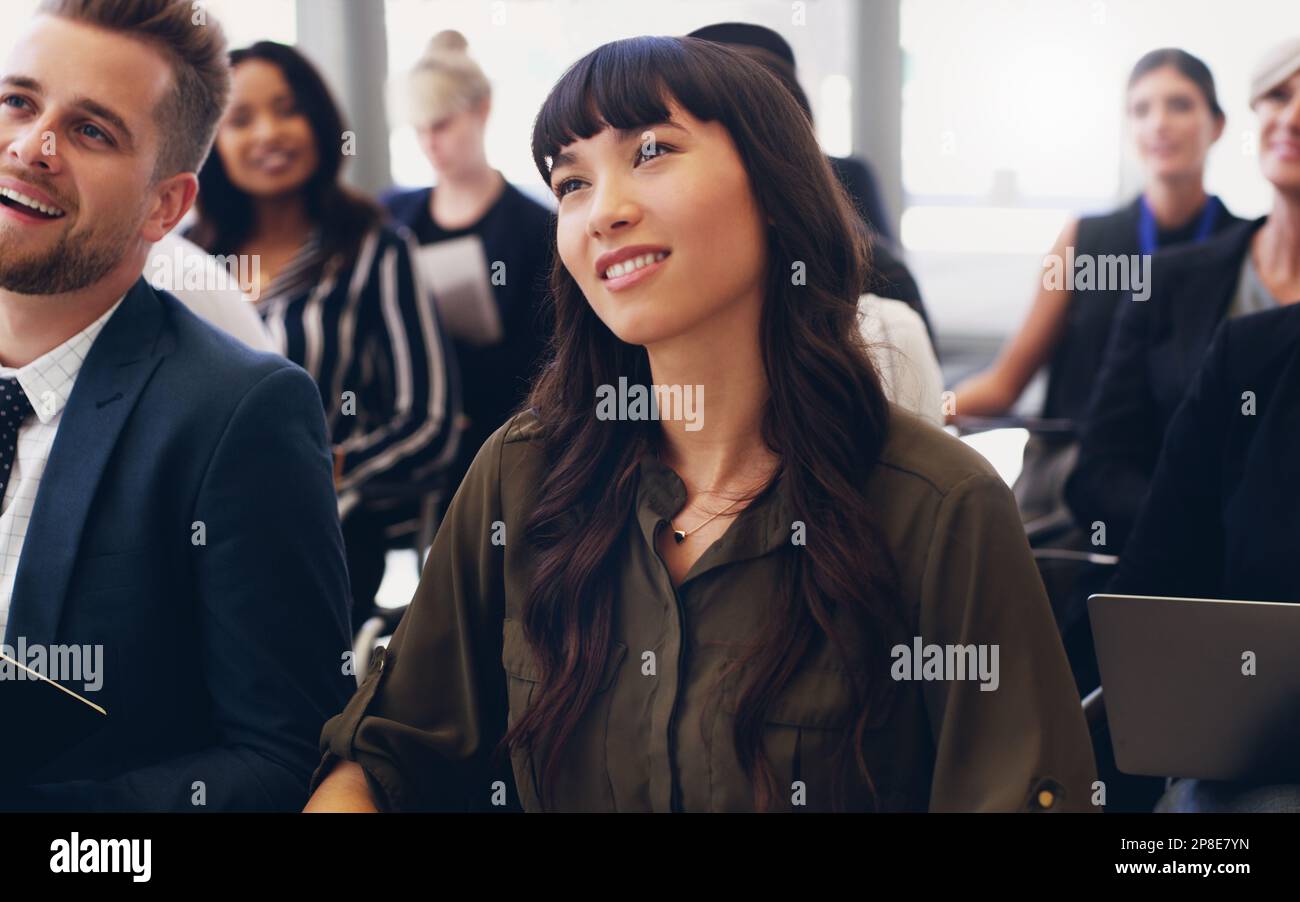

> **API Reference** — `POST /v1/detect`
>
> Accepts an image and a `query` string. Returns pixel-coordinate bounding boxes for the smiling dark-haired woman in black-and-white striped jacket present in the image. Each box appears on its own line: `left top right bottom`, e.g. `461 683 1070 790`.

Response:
189 42 454 636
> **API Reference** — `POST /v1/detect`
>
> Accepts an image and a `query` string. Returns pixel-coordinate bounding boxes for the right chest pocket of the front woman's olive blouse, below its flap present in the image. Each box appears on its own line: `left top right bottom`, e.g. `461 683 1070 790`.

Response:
712 668 865 812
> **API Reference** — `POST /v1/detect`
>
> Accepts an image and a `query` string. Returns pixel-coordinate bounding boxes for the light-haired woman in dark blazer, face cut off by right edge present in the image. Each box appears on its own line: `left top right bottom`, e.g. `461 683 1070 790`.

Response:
1065 42 1300 554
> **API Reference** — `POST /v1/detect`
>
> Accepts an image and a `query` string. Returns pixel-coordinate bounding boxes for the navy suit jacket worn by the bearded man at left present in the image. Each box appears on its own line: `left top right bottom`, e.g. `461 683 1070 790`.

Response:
0 278 356 811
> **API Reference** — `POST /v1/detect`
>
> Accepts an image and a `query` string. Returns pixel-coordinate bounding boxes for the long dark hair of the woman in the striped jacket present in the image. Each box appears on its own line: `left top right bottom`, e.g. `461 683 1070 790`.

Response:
187 40 384 274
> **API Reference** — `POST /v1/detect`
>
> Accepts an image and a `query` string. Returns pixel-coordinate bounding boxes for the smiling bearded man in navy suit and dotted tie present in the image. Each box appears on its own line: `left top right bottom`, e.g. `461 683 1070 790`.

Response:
0 0 355 811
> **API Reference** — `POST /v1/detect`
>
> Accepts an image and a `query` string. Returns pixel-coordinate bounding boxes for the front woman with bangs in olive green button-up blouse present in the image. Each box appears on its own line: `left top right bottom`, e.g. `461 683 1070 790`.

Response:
308 38 1095 811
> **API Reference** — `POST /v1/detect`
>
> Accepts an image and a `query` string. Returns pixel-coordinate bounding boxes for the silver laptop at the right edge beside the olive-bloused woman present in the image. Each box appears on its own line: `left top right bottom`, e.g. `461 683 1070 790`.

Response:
1088 595 1300 782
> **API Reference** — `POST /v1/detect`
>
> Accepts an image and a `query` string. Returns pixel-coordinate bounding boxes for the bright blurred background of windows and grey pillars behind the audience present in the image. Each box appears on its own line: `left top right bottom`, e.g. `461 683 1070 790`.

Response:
0 0 1300 360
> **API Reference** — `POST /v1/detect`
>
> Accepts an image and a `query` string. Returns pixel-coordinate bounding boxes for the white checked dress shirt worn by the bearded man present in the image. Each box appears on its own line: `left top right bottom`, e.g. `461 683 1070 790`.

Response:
0 295 125 637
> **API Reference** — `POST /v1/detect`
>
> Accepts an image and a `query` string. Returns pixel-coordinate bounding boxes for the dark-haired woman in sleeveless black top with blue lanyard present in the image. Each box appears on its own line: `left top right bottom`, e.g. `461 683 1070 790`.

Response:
956 48 1240 521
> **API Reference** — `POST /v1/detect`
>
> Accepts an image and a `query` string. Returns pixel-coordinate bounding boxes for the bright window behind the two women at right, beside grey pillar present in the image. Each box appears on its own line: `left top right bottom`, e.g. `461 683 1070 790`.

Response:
900 0 1296 333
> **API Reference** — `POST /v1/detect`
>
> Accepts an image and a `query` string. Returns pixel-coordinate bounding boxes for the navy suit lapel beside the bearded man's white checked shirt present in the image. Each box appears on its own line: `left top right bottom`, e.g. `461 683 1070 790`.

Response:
4 278 165 646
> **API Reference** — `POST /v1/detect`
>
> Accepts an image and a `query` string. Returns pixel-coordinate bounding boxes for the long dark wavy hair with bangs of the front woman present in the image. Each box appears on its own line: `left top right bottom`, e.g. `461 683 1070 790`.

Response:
502 38 902 810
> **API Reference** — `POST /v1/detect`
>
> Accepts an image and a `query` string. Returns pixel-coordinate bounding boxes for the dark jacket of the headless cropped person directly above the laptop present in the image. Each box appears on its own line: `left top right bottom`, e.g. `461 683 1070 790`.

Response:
1112 303 1300 602
